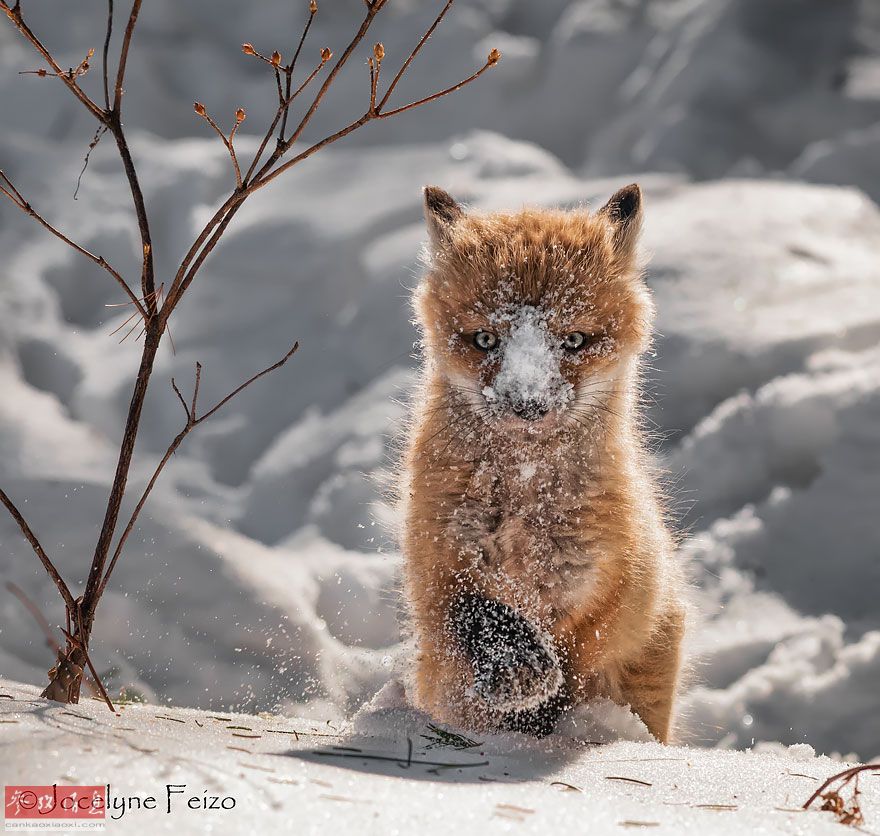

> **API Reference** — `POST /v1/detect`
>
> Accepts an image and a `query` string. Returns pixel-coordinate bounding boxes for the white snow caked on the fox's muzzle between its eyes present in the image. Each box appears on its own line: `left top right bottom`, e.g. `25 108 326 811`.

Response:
483 305 572 420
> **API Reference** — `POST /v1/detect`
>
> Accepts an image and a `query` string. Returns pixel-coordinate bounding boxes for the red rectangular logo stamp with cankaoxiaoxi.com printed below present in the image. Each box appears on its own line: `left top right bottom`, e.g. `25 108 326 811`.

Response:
4 784 107 830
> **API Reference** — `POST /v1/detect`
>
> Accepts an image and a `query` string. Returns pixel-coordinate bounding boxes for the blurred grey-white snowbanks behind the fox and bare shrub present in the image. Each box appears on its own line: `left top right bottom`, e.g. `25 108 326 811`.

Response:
0 0 880 758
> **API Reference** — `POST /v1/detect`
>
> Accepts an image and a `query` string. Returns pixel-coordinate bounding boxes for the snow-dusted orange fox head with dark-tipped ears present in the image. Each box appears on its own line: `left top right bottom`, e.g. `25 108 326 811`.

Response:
415 185 653 433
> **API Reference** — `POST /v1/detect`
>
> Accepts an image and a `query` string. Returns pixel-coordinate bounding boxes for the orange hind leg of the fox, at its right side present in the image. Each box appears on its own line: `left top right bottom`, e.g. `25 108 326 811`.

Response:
620 609 684 743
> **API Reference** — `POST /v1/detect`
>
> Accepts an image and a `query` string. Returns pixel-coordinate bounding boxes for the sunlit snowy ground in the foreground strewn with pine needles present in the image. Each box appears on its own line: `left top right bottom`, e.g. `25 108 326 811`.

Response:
0 680 880 836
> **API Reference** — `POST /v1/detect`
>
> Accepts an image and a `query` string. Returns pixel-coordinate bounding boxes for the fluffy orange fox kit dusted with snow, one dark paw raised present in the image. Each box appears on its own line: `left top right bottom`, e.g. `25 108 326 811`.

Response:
402 185 684 742
